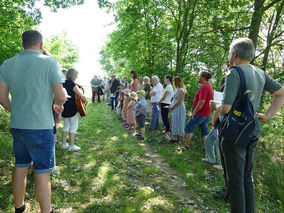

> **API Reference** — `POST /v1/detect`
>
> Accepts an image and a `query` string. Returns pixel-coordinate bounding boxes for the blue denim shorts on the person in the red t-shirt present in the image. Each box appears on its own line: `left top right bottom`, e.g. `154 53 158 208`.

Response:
185 114 209 136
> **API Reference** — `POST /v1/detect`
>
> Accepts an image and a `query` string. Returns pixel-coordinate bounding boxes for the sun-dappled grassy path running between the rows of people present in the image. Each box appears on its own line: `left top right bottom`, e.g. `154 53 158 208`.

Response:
53 104 213 212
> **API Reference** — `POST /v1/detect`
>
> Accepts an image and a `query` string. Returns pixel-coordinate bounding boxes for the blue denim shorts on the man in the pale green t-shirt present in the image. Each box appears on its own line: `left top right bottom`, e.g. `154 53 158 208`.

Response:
10 129 55 174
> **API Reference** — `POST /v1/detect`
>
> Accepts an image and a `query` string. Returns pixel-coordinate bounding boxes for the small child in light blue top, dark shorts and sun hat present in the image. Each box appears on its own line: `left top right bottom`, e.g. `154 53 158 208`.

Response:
135 90 147 140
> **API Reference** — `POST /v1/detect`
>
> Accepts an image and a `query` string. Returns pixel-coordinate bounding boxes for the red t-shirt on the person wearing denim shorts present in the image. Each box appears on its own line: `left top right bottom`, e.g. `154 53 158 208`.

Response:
193 82 213 117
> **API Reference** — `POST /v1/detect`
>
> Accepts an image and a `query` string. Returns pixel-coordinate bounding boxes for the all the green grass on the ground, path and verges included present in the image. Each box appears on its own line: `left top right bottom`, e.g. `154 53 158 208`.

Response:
0 103 284 213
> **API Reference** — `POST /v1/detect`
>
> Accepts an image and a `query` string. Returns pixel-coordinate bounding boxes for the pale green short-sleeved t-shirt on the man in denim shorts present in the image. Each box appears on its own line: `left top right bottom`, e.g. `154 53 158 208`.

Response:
0 50 64 130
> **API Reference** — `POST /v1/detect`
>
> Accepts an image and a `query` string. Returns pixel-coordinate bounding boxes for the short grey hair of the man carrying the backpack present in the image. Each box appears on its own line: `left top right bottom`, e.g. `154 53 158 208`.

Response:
229 38 255 61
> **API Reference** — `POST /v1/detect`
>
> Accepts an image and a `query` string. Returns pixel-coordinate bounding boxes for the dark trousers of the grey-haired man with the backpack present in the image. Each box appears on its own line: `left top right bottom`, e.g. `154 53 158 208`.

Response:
220 138 258 213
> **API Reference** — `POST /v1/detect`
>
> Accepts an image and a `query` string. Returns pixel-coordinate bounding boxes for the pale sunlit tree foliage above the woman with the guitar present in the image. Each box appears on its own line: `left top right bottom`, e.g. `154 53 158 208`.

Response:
44 32 79 69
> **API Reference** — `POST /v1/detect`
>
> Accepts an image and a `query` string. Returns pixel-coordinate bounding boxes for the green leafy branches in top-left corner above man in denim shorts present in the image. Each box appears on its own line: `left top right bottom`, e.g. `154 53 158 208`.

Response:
0 0 84 64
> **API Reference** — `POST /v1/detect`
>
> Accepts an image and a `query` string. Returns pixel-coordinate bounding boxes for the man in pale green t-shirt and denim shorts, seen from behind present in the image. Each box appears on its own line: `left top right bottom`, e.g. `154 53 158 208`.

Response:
0 30 65 212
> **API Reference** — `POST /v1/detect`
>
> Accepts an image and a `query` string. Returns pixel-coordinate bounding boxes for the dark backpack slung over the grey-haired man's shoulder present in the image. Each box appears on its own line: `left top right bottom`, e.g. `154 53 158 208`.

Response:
218 66 255 148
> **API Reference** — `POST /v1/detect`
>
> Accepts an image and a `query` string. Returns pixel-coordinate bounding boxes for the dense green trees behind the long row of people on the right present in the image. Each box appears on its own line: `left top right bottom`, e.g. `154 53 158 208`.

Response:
98 0 284 88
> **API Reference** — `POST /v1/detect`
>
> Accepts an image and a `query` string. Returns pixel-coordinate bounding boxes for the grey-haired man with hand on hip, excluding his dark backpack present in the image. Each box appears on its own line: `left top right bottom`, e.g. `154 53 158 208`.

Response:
220 38 284 213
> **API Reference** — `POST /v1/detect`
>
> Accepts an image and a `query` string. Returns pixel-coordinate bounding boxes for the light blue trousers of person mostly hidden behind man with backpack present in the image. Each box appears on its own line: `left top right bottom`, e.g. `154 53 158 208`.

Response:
205 128 220 164
